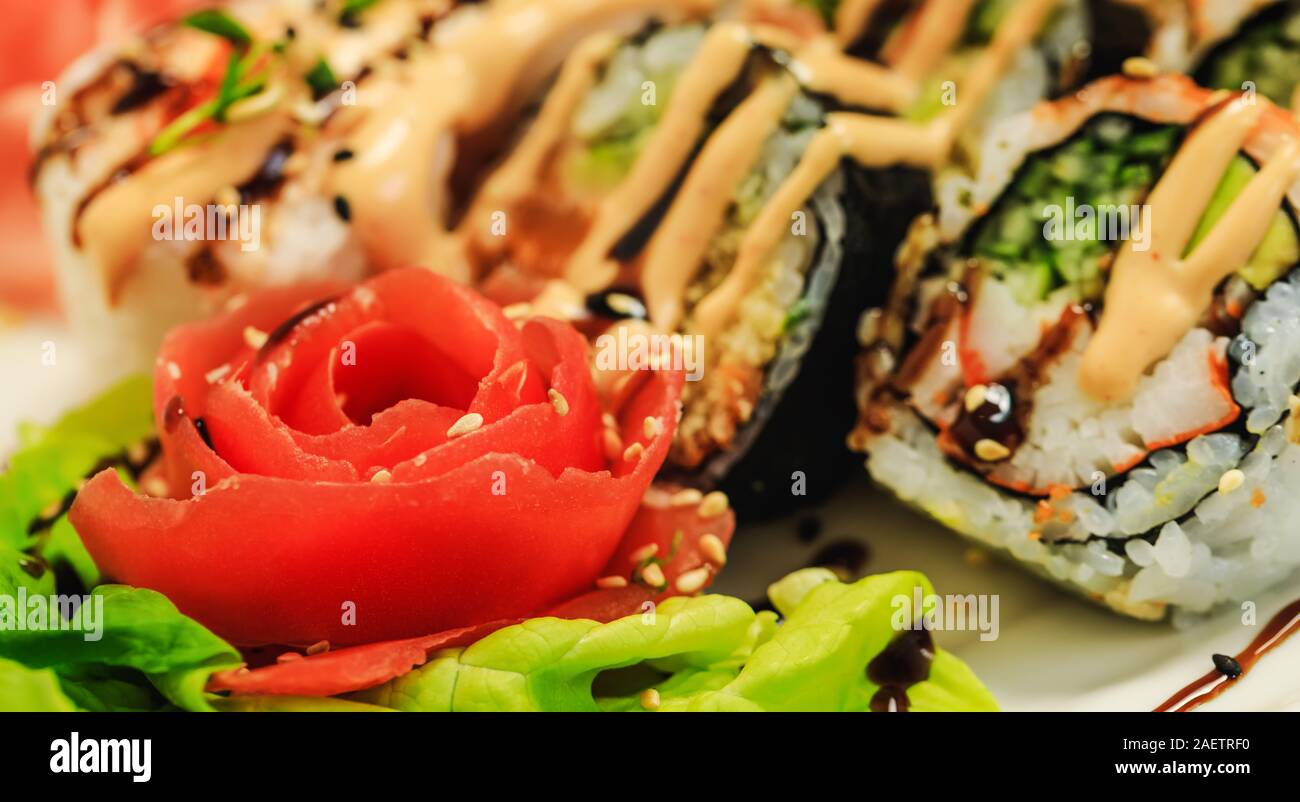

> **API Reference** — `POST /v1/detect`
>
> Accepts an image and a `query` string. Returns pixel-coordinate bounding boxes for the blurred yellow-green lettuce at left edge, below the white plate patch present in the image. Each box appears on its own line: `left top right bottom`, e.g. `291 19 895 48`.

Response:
0 377 153 549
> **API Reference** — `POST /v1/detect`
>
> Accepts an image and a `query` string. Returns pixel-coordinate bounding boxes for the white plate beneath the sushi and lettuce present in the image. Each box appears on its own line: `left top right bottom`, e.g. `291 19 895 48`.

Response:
0 322 1300 711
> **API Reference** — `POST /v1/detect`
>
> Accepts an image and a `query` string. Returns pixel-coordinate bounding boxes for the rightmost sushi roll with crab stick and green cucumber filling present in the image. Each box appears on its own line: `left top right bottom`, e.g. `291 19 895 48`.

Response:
850 70 1300 619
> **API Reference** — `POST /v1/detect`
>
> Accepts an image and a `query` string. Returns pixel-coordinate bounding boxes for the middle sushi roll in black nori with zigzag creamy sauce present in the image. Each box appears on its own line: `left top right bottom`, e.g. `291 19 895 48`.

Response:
459 0 1082 516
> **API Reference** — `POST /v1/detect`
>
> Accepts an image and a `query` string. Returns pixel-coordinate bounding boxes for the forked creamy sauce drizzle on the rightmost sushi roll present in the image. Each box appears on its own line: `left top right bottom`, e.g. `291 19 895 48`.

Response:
1079 99 1300 402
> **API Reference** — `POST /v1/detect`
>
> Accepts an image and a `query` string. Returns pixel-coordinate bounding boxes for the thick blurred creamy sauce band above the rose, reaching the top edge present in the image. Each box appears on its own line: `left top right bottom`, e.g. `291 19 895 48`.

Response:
334 0 714 281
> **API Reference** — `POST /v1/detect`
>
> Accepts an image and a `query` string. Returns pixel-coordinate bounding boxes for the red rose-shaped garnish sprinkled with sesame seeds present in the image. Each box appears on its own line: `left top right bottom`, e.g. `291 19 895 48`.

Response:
70 269 732 647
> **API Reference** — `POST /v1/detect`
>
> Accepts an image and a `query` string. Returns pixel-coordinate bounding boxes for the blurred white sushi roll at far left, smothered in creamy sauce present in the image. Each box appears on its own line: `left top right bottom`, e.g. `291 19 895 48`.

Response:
31 0 712 380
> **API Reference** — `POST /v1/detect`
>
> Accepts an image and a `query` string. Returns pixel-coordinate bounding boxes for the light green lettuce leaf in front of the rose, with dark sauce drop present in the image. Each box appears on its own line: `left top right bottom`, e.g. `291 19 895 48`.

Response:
352 571 997 711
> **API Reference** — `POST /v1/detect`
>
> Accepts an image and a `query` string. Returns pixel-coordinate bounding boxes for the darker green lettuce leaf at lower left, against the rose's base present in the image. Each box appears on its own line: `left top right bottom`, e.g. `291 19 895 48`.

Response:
0 585 243 711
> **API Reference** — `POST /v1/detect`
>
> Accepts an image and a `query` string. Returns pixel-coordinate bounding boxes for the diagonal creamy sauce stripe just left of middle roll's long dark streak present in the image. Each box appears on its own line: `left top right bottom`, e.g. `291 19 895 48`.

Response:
566 23 751 292
